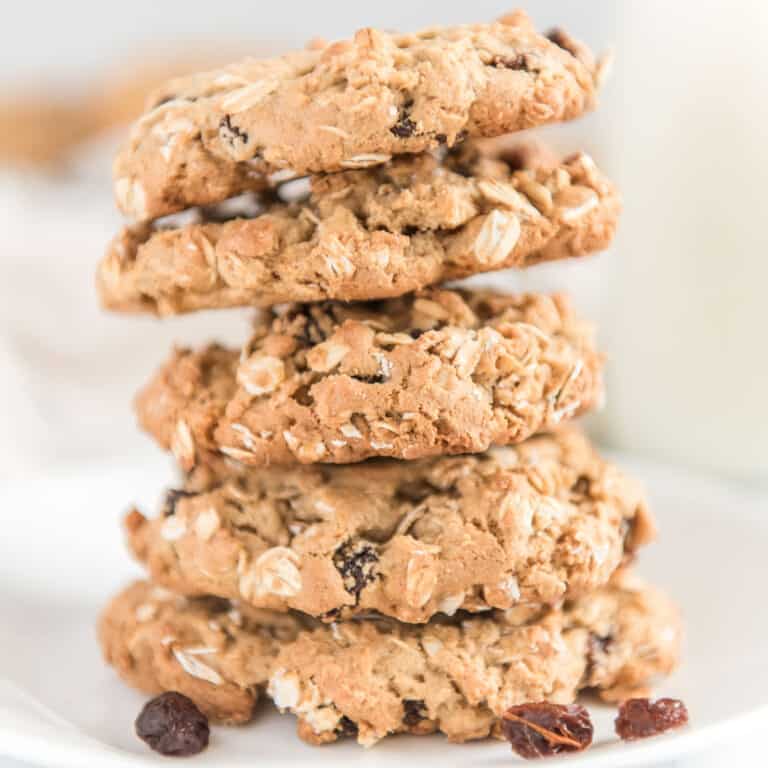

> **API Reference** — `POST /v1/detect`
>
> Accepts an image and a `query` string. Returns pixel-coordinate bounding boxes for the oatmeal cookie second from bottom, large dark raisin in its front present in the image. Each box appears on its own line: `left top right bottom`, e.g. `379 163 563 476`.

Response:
126 429 654 622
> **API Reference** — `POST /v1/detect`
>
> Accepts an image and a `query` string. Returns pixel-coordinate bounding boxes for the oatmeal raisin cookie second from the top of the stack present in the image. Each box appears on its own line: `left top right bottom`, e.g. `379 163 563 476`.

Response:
98 142 620 315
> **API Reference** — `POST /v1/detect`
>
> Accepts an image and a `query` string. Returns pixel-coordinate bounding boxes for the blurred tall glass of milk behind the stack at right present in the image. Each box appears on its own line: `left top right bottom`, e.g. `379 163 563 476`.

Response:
488 0 768 483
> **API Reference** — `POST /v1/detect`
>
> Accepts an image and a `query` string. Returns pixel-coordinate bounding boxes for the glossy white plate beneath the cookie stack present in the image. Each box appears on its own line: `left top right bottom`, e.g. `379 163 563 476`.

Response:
0 452 768 768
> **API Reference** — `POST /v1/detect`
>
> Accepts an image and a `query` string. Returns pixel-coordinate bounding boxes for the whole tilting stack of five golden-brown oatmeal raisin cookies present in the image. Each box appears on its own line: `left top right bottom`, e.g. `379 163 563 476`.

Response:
98 12 679 746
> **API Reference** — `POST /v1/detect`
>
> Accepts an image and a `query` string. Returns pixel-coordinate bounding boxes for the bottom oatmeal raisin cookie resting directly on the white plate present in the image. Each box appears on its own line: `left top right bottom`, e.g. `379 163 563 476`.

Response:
100 574 680 746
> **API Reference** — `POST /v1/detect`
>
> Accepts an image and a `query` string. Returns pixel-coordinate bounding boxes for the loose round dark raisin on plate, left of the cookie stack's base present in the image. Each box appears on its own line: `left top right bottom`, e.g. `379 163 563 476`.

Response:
136 691 210 756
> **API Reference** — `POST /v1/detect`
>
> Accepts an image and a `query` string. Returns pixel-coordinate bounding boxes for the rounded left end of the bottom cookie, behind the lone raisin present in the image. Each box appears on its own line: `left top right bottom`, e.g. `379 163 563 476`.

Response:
99 581 304 723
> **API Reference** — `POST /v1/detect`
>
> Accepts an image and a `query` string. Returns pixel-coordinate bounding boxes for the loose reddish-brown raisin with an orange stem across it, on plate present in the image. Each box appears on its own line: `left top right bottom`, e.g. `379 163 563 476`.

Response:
501 701 594 758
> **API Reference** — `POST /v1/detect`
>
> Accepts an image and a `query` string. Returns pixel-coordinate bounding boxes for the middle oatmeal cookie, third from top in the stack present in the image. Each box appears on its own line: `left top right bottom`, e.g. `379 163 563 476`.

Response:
137 290 602 470
